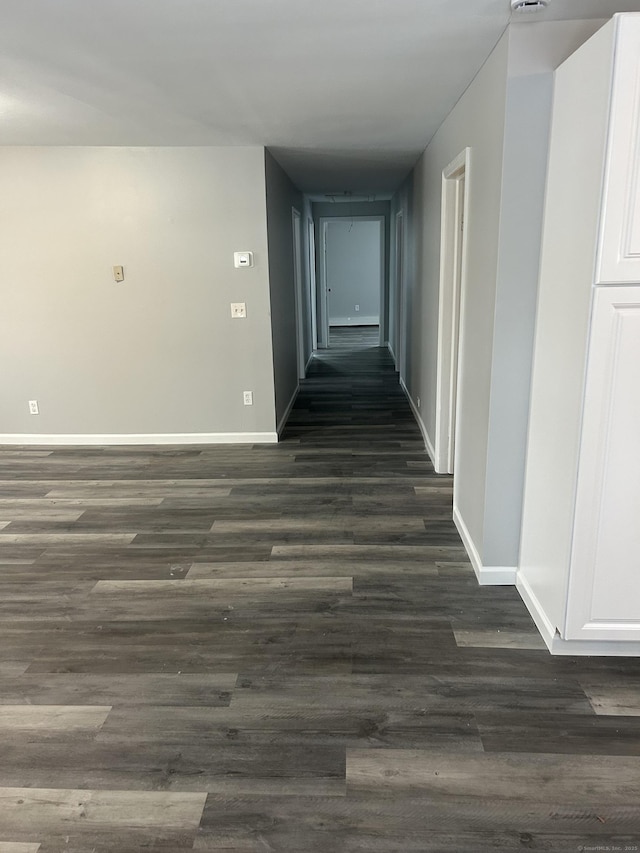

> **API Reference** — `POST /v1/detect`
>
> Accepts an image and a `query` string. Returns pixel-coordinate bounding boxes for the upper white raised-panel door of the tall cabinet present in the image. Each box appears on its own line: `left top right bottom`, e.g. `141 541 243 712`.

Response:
596 14 640 284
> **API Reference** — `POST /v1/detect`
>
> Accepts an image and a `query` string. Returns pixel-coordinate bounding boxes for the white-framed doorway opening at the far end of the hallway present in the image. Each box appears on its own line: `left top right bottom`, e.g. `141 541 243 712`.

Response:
318 216 386 347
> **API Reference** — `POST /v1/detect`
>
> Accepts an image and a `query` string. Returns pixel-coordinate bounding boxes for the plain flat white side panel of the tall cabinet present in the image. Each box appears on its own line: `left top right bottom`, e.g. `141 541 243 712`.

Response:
519 24 615 633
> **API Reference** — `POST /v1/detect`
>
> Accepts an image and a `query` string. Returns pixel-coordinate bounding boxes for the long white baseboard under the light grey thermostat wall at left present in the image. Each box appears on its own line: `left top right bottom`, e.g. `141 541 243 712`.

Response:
0 432 278 446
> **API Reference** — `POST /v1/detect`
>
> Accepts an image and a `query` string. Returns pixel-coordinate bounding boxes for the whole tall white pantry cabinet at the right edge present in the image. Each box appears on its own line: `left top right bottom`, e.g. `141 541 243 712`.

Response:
517 13 640 655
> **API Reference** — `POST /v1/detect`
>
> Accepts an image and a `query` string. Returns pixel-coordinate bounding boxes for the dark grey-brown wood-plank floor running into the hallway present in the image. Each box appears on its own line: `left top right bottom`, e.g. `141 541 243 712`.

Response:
0 330 640 853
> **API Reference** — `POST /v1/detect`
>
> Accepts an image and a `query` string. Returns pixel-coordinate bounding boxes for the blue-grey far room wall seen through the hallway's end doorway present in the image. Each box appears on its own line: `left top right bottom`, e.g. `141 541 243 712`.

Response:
326 218 384 326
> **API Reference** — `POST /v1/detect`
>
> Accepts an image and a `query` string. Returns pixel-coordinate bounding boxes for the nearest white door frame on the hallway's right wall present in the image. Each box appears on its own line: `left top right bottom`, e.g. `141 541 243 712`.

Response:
434 148 471 474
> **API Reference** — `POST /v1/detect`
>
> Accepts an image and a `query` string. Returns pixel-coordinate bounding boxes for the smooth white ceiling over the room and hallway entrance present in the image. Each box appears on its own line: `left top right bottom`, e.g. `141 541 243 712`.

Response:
0 0 640 192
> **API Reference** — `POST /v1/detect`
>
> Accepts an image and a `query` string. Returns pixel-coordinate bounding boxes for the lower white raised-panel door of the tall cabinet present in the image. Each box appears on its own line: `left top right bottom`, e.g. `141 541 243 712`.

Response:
564 285 640 641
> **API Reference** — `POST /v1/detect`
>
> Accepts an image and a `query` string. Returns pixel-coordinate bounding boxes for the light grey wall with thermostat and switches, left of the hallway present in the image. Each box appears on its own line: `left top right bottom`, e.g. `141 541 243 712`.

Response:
0 147 275 440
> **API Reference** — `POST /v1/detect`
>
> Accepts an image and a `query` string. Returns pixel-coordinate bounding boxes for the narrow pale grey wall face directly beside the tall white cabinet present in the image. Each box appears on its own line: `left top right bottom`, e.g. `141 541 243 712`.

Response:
481 20 604 567
